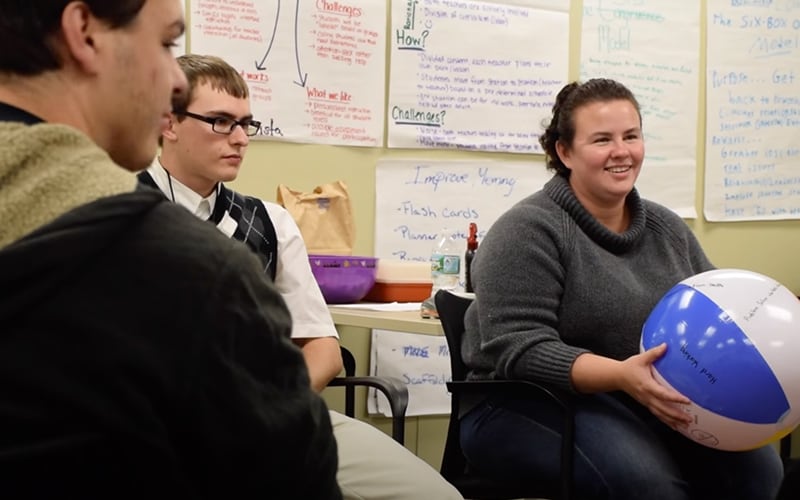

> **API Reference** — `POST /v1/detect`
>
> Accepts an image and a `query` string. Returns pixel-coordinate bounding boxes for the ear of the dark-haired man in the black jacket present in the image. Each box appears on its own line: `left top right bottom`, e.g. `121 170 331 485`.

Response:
61 2 108 73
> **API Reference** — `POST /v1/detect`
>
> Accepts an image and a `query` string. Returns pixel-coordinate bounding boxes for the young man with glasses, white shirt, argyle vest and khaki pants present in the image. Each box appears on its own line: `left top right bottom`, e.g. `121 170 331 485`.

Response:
140 54 461 500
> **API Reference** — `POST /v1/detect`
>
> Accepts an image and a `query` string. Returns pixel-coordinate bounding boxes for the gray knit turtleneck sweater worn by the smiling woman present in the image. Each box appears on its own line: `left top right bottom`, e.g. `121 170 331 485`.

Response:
463 176 713 389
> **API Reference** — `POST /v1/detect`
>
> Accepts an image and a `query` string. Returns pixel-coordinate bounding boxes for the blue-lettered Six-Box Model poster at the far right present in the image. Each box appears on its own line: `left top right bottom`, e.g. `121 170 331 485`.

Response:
705 0 800 221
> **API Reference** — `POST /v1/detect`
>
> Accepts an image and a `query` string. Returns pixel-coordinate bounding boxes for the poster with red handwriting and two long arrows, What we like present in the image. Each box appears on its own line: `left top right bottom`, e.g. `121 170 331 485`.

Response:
189 0 387 147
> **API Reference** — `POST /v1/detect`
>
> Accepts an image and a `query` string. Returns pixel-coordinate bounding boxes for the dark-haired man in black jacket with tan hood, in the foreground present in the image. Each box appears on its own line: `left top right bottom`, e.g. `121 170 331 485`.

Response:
0 0 341 500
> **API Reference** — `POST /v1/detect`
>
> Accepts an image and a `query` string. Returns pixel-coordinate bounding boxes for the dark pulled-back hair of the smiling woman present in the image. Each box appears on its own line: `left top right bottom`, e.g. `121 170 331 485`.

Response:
539 78 642 177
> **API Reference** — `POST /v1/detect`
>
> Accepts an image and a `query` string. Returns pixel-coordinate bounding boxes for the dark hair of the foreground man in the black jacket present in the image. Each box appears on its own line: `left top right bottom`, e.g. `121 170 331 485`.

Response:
0 0 147 76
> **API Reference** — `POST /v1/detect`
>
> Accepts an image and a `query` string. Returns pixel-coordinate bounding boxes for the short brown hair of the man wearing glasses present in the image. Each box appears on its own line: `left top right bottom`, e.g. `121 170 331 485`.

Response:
173 54 250 114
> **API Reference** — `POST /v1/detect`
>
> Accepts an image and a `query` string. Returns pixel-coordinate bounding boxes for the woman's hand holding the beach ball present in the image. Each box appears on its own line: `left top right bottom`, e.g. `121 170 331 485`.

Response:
620 344 692 430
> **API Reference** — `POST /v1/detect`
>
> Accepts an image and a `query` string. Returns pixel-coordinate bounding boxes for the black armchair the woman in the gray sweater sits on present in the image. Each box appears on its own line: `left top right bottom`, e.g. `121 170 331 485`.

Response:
434 290 575 500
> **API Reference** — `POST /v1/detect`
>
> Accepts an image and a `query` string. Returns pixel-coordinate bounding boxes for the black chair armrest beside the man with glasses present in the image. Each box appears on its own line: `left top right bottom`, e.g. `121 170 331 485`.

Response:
328 347 408 444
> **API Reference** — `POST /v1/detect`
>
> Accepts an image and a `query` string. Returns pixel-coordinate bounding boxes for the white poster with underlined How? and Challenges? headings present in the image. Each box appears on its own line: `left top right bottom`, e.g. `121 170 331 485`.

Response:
386 0 569 153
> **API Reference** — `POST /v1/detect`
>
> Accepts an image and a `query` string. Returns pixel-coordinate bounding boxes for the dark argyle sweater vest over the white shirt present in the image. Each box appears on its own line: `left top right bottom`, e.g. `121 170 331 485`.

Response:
138 172 278 281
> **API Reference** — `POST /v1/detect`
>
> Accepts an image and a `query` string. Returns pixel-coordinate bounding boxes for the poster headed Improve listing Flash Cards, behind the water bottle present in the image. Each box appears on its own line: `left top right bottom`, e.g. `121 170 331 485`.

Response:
375 160 553 274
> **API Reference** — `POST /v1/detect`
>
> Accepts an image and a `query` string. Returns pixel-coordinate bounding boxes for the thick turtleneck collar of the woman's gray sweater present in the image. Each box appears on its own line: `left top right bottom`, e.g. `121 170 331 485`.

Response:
544 175 647 254
